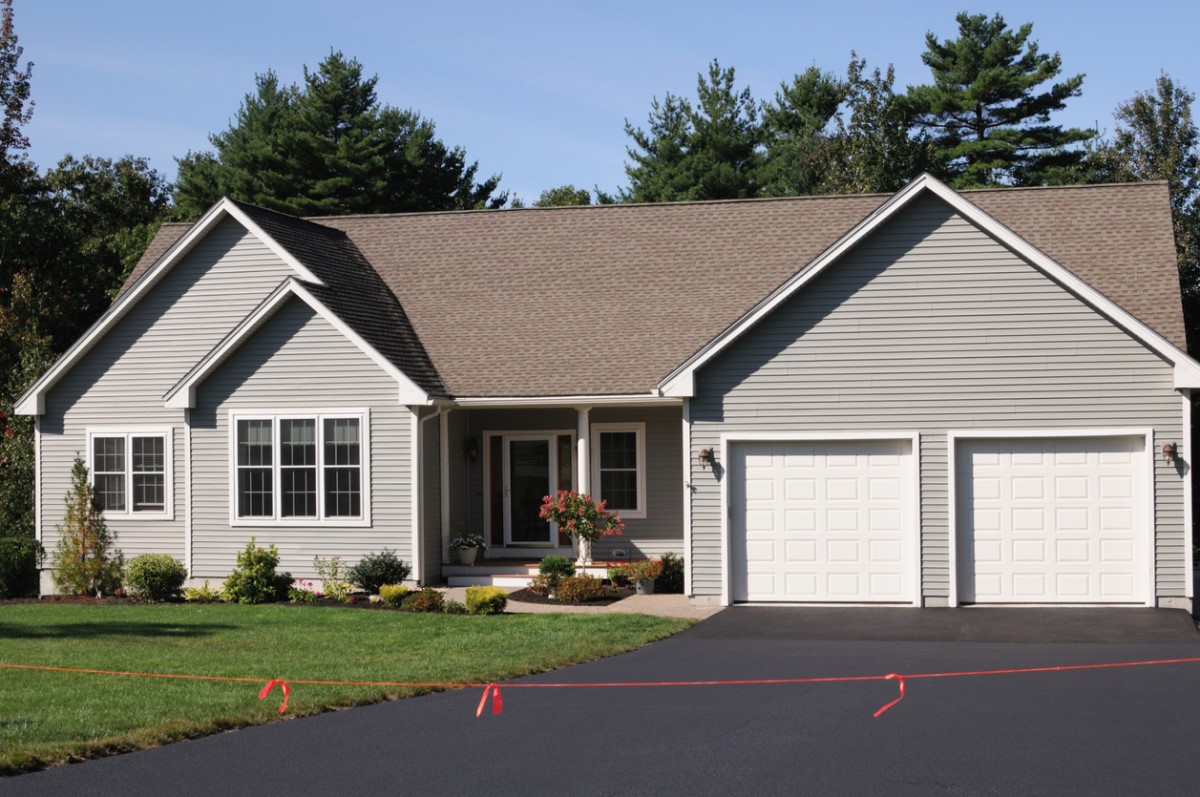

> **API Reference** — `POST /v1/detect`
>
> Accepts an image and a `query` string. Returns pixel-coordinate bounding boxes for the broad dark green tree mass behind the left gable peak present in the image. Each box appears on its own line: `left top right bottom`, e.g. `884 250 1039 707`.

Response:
175 53 506 218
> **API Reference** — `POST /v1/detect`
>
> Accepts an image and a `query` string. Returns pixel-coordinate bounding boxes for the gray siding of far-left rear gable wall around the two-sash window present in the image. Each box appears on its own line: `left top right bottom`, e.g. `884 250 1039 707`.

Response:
38 220 293 559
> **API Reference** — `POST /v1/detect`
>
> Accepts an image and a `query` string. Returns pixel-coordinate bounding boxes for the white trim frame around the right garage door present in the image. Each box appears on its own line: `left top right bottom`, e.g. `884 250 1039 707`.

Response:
946 427 1152 607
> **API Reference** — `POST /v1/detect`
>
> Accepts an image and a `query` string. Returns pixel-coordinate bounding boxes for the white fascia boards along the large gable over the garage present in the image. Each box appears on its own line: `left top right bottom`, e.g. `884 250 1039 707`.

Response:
659 174 1200 396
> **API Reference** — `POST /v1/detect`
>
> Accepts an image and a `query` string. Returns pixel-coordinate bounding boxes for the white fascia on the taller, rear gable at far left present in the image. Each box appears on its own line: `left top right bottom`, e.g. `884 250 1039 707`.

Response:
13 197 324 415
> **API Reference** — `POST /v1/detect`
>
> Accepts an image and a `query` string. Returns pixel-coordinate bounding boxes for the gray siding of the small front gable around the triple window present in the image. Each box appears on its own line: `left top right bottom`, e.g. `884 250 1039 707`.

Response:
192 299 413 579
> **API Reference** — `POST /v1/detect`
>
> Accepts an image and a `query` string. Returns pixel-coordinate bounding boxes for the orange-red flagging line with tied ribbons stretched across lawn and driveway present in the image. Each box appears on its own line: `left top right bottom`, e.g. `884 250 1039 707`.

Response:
0 657 1200 717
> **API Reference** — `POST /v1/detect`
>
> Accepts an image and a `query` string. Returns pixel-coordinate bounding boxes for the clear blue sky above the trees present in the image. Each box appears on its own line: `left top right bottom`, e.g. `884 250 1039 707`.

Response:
13 0 1200 200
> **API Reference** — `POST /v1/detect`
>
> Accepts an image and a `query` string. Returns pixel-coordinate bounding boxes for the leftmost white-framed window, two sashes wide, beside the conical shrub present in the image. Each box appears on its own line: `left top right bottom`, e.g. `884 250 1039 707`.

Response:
88 430 170 517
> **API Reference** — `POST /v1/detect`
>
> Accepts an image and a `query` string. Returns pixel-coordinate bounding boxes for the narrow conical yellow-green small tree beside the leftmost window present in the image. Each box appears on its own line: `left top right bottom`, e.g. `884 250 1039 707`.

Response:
53 456 125 595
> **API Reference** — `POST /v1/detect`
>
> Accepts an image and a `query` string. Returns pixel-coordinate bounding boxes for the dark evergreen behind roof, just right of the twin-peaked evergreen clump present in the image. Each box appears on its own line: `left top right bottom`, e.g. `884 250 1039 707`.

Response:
762 66 847 197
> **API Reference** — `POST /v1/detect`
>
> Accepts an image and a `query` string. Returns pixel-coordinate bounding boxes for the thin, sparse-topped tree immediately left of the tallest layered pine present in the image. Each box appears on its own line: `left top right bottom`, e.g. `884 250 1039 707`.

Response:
828 53 929 193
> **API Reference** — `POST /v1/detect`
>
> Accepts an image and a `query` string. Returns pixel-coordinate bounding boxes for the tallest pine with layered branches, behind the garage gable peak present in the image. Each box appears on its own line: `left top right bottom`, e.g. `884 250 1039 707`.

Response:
908 12 1096 188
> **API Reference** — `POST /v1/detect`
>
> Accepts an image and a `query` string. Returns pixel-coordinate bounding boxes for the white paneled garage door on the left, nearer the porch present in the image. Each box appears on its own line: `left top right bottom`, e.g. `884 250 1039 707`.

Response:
730 439 917 603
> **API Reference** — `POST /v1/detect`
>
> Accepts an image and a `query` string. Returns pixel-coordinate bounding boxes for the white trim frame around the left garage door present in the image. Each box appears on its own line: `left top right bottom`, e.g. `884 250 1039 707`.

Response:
714 430 924 606
